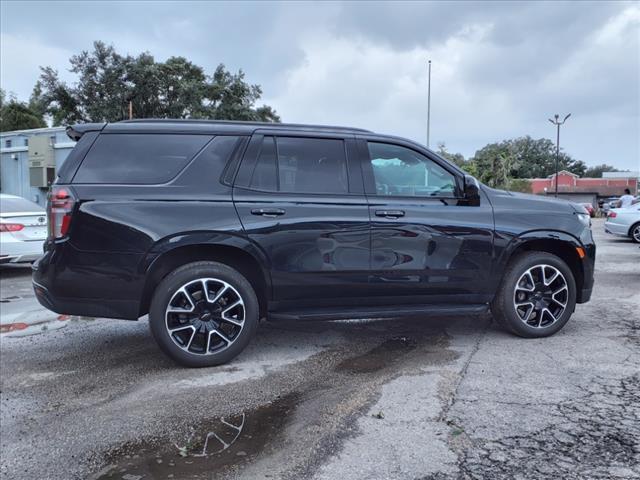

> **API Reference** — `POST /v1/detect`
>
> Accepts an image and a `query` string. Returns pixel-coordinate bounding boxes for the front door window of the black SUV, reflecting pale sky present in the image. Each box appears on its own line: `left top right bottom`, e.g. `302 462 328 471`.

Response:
368 142 456 197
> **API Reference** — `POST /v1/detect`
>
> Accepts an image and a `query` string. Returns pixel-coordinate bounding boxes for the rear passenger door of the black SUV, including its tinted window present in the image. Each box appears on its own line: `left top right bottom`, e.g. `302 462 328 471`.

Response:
233 131 370 306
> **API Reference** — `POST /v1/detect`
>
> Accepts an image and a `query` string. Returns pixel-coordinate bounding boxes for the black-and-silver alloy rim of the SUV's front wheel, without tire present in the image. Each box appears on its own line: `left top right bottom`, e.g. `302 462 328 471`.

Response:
513 265 569 328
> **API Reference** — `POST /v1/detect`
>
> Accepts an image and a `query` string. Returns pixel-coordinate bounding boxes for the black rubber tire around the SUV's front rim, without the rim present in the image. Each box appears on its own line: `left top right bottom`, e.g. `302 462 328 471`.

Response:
491 252 576 338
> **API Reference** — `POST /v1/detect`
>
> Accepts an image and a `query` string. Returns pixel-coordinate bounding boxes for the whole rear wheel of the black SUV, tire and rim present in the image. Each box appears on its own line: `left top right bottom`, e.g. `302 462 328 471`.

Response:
149 262 259 367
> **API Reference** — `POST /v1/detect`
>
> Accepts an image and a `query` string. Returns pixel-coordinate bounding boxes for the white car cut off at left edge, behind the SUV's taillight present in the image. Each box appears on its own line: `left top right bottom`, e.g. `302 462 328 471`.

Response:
0 193 47 264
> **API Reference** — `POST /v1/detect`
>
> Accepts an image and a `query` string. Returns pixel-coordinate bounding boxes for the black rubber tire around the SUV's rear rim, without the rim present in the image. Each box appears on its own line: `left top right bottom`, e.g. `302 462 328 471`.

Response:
149 261 259 367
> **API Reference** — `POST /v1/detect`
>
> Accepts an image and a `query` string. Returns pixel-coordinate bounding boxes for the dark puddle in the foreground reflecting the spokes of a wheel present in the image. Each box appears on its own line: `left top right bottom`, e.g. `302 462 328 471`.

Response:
92 393 300 480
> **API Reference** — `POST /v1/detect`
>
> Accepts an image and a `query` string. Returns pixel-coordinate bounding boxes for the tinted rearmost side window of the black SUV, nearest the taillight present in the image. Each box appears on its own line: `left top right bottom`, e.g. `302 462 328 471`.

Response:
73 133 211 185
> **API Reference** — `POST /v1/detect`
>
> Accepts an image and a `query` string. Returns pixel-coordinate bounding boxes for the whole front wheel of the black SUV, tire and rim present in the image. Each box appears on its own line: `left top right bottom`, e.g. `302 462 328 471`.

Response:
491 252 576 338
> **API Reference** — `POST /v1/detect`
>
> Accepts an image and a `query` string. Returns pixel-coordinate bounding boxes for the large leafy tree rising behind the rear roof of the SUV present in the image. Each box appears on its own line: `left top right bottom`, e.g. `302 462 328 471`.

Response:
31 41 280 125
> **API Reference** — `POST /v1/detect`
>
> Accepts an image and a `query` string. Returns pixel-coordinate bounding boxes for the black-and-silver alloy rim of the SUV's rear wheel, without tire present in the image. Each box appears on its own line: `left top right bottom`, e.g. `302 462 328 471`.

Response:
165 278 245 355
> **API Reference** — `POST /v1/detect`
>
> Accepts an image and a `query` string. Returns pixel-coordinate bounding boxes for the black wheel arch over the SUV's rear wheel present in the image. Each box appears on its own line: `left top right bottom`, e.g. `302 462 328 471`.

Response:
139 232 271 317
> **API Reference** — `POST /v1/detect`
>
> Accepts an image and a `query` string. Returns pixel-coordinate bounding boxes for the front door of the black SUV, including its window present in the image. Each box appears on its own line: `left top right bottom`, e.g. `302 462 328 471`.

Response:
357 137 494 304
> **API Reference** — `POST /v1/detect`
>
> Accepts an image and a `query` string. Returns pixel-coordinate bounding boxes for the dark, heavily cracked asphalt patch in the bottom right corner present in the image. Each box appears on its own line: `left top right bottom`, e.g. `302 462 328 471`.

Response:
440 375 640 480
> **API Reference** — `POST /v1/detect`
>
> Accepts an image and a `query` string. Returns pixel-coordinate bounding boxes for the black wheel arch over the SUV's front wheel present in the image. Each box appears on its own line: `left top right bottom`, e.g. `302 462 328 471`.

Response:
499 231 585 303
